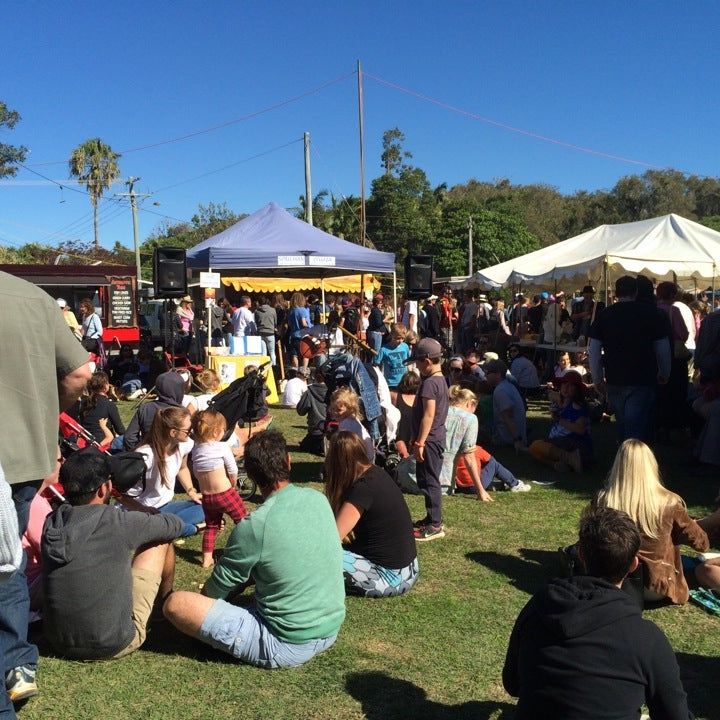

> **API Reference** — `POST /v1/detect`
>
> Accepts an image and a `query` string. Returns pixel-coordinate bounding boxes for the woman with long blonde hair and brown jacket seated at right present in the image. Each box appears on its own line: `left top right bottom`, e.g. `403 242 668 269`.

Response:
596 438 709 605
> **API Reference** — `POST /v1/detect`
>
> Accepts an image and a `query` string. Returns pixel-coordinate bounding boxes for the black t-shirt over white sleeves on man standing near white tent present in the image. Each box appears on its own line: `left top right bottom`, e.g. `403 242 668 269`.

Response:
590 300 670 386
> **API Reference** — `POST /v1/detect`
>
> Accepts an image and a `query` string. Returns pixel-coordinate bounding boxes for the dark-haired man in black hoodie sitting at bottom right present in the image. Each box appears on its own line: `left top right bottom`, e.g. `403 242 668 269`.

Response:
503 507 691 720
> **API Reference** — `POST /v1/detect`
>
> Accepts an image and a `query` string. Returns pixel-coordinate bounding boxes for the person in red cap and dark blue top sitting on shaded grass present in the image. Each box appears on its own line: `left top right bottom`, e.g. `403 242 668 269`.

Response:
528 370 593 472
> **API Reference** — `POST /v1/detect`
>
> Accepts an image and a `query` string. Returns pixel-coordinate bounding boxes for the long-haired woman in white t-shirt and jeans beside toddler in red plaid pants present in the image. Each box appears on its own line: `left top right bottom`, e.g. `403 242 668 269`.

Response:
126 407 205 537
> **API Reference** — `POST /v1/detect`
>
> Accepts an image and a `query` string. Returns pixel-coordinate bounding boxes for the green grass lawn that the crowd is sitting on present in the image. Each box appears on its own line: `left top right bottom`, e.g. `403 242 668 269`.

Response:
19 403 720 720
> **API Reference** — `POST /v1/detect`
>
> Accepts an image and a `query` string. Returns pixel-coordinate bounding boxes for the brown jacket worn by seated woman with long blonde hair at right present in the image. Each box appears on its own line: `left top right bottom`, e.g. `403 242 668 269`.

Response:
638 502 710 605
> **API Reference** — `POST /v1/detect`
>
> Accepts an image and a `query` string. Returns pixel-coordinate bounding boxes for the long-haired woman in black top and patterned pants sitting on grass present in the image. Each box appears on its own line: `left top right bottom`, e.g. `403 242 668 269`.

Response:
324 431 418 597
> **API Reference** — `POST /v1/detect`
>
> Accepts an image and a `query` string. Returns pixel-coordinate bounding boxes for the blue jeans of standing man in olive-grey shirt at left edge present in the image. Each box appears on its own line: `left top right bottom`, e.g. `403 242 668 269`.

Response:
0 482 40 696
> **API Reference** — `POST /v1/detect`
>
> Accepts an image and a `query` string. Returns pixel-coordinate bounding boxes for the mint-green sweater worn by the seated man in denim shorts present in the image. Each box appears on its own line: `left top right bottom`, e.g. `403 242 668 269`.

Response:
205 485 345 644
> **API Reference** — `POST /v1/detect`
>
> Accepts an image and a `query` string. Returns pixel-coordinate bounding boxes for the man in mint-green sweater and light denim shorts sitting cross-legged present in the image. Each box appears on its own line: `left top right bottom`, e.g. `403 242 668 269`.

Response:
164 430 345 668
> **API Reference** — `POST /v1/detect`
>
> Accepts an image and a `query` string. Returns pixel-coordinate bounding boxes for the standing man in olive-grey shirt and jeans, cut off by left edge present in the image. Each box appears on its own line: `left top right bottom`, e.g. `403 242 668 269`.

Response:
0 272 90 720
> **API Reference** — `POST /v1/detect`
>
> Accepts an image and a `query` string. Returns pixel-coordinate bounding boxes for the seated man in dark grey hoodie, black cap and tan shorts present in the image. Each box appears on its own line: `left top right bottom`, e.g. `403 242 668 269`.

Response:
41 448 184 660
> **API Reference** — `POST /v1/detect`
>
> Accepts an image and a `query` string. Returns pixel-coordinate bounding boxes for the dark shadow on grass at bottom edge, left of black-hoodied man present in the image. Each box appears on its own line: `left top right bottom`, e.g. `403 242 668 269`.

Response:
345 672 515 720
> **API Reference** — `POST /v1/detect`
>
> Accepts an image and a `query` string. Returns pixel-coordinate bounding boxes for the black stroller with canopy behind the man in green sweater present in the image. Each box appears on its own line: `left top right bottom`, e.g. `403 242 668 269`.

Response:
208 362 270 500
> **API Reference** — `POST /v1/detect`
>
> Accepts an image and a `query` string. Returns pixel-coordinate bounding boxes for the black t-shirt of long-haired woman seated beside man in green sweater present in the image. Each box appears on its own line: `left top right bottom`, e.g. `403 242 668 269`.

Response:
346 465 417 570
